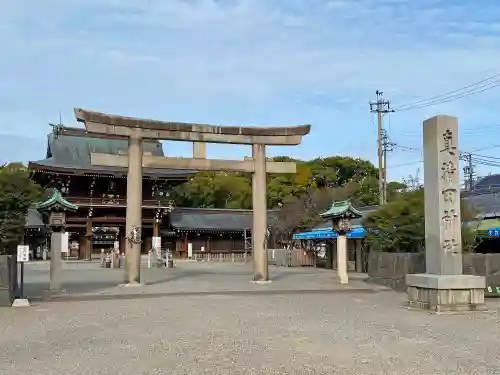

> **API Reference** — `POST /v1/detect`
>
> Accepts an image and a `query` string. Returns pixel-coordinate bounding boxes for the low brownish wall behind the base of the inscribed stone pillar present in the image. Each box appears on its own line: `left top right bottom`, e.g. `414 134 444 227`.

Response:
368 251 500 292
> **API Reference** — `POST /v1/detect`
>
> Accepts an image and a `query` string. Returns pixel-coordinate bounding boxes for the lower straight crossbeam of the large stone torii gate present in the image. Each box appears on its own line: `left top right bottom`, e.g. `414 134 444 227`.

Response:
90 153 297 174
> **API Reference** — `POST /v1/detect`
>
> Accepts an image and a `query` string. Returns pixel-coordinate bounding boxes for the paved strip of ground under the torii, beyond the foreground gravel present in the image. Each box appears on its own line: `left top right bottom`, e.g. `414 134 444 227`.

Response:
21 261 386 300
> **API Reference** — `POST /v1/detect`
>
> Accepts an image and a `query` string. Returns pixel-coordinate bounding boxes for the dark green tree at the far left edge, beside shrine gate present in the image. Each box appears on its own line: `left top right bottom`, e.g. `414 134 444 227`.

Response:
0 163 42 254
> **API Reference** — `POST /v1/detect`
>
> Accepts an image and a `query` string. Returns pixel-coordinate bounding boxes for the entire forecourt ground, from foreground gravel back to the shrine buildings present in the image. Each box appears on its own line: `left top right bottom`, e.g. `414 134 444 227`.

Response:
0 263 500 375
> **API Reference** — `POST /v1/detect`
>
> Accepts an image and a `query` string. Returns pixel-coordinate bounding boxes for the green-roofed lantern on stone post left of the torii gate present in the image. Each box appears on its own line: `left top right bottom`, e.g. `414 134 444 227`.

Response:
36 189 78 293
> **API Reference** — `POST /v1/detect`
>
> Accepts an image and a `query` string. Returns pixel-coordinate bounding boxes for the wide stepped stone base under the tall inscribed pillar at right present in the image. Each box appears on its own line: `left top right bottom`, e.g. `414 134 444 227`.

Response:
406 273 486 314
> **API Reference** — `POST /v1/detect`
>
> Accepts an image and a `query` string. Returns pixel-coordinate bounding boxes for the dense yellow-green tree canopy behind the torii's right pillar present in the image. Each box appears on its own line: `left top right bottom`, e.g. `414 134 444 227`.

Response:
173 156 378 209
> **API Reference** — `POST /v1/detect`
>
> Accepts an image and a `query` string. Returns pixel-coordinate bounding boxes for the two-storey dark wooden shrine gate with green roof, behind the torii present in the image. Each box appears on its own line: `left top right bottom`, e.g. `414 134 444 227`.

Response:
26 126 195 259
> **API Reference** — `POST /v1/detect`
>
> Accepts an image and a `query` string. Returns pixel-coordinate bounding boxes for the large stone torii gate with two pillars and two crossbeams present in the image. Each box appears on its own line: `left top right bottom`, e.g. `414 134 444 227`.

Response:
72 108 311 285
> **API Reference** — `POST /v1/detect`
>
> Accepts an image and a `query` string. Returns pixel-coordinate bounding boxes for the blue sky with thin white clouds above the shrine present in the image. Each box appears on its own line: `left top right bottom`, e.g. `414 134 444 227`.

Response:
0 0 500 179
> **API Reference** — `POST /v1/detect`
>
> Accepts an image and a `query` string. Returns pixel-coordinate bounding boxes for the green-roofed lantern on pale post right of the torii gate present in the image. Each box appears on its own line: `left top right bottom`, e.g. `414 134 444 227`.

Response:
320 200 362 284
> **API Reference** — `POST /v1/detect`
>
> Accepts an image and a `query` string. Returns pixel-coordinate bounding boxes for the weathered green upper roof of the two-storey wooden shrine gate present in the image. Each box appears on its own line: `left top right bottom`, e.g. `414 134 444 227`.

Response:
26 133 196 177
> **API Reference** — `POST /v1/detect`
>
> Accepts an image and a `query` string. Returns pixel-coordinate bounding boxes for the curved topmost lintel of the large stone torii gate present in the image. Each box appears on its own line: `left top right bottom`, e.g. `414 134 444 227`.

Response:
74 108 311 146
